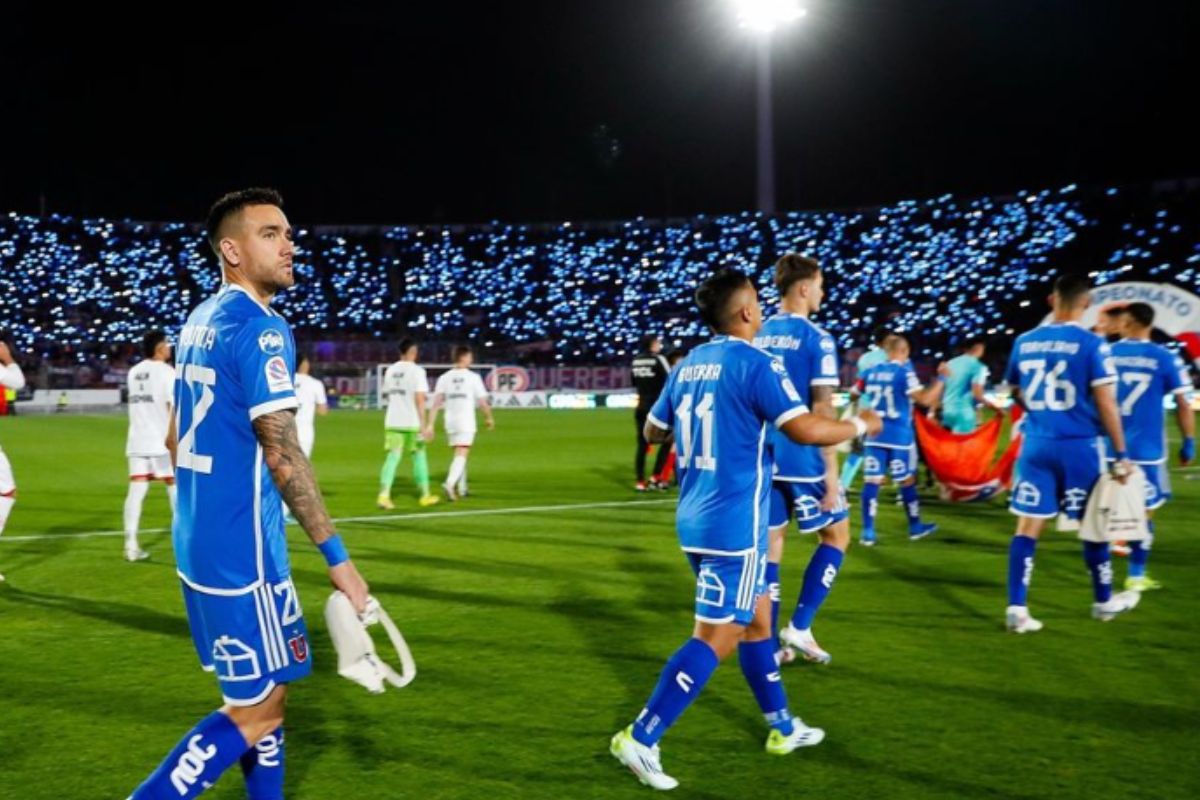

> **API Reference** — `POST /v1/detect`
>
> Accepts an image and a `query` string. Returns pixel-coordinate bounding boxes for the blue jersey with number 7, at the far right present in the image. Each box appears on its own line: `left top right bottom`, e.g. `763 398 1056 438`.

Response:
1112 339 1192 464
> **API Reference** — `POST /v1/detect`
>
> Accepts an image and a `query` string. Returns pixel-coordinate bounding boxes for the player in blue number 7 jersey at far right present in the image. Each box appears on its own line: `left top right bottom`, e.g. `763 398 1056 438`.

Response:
1112 302 1196 591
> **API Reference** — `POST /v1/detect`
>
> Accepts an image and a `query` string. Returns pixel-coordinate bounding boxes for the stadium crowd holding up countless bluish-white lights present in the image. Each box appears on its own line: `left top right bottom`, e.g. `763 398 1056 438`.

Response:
0 182 1200 385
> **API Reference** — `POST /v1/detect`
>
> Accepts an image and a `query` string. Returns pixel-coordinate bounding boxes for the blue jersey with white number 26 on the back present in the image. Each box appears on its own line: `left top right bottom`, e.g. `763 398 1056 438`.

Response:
1004 323 1117 439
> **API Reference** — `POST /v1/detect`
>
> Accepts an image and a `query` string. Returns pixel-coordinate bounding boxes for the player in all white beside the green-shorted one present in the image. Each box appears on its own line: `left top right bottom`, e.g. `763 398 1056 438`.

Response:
425 345 496 503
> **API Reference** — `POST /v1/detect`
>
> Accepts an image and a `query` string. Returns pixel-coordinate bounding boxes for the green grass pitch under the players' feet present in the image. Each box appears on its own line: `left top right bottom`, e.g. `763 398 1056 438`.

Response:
0 410 1200 800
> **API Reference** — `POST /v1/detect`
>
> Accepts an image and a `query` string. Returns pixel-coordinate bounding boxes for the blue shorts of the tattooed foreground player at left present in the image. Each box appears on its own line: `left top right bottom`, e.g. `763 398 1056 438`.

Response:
184 578 312 705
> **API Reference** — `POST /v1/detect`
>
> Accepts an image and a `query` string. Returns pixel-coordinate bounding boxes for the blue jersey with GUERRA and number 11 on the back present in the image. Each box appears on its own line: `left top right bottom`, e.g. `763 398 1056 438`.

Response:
648 336 808 555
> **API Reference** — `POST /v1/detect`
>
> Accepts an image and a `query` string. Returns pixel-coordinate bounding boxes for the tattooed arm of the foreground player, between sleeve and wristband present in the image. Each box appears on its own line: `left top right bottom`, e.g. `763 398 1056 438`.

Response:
253 410 335 545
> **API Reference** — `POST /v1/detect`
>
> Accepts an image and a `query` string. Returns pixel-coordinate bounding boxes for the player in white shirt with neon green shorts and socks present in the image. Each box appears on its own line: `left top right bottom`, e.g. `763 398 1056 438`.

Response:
376 339 438 509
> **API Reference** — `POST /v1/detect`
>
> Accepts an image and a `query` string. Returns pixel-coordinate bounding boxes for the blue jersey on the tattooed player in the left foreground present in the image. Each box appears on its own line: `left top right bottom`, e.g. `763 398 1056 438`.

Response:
172 284 298 594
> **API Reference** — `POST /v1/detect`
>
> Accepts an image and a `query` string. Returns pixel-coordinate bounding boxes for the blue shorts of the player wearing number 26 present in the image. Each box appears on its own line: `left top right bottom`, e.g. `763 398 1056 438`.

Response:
1008 437 1104 519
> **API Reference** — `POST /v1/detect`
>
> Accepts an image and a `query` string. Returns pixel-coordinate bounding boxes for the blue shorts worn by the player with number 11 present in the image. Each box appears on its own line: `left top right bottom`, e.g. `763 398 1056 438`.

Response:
686 536 767 625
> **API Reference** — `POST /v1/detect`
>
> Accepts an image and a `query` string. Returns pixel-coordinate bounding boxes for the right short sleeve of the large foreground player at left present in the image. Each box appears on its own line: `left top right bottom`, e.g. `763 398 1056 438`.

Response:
233 317 299 420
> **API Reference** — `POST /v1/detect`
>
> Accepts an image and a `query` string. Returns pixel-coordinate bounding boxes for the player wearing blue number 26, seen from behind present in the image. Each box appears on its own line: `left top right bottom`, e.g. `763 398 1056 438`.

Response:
1004 275 1139 633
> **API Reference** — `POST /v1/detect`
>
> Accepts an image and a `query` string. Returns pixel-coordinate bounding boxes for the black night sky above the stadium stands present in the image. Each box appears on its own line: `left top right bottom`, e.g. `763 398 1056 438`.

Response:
0 0 1200 224
